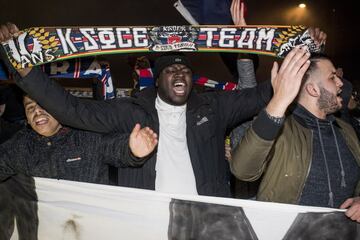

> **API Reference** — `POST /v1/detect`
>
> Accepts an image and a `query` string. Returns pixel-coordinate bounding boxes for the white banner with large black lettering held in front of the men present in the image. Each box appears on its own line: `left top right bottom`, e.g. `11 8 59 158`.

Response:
0 178 360 240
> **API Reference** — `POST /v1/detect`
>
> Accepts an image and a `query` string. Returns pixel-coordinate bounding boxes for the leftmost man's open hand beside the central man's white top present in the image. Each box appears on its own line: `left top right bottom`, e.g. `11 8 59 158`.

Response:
129 123 158 158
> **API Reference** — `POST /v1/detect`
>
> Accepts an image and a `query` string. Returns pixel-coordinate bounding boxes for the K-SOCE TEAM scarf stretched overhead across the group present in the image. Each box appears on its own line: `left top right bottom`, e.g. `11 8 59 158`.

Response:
3 25 320 69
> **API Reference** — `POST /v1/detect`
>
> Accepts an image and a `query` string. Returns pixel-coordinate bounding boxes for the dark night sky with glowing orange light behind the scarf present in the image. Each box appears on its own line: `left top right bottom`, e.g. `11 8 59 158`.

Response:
0 0 360 87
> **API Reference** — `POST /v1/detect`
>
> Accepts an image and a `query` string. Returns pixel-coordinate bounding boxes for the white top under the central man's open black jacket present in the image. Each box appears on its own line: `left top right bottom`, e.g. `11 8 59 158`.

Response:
155 96 198 195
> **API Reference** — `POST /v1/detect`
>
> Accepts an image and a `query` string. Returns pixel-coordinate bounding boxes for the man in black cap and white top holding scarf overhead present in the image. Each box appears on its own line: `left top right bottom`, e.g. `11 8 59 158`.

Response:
0 24 323 197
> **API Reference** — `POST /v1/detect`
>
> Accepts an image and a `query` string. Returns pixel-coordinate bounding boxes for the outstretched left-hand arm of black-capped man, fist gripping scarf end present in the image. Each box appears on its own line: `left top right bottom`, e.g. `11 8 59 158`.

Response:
0 23 136 132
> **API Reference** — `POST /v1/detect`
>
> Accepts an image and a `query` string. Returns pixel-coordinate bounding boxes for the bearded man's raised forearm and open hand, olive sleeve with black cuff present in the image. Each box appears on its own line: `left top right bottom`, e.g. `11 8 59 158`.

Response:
230 48 310 181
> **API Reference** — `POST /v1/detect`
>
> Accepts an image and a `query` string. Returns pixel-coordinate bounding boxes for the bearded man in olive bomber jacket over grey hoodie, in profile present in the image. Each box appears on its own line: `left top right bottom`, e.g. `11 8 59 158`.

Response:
231 55 360 222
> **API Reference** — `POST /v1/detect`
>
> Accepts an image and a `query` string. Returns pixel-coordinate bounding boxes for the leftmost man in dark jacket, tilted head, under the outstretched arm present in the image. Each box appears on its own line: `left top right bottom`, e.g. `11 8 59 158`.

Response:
0 96 157 184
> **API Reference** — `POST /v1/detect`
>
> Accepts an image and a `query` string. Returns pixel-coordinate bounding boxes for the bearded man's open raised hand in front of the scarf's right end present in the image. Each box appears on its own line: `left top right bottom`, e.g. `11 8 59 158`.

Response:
266 47 310 117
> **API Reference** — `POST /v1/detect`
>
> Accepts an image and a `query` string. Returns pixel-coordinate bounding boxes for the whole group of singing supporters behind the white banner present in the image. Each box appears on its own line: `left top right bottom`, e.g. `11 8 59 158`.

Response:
0 0 360 230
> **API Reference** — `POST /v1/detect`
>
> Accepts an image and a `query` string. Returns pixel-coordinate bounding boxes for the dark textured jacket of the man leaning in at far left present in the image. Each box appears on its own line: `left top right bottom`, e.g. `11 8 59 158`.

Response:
0 128 145 184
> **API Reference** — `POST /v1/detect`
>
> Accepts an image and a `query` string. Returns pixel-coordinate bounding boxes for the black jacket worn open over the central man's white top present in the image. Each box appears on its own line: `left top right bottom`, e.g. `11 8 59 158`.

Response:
17 68 272 197
